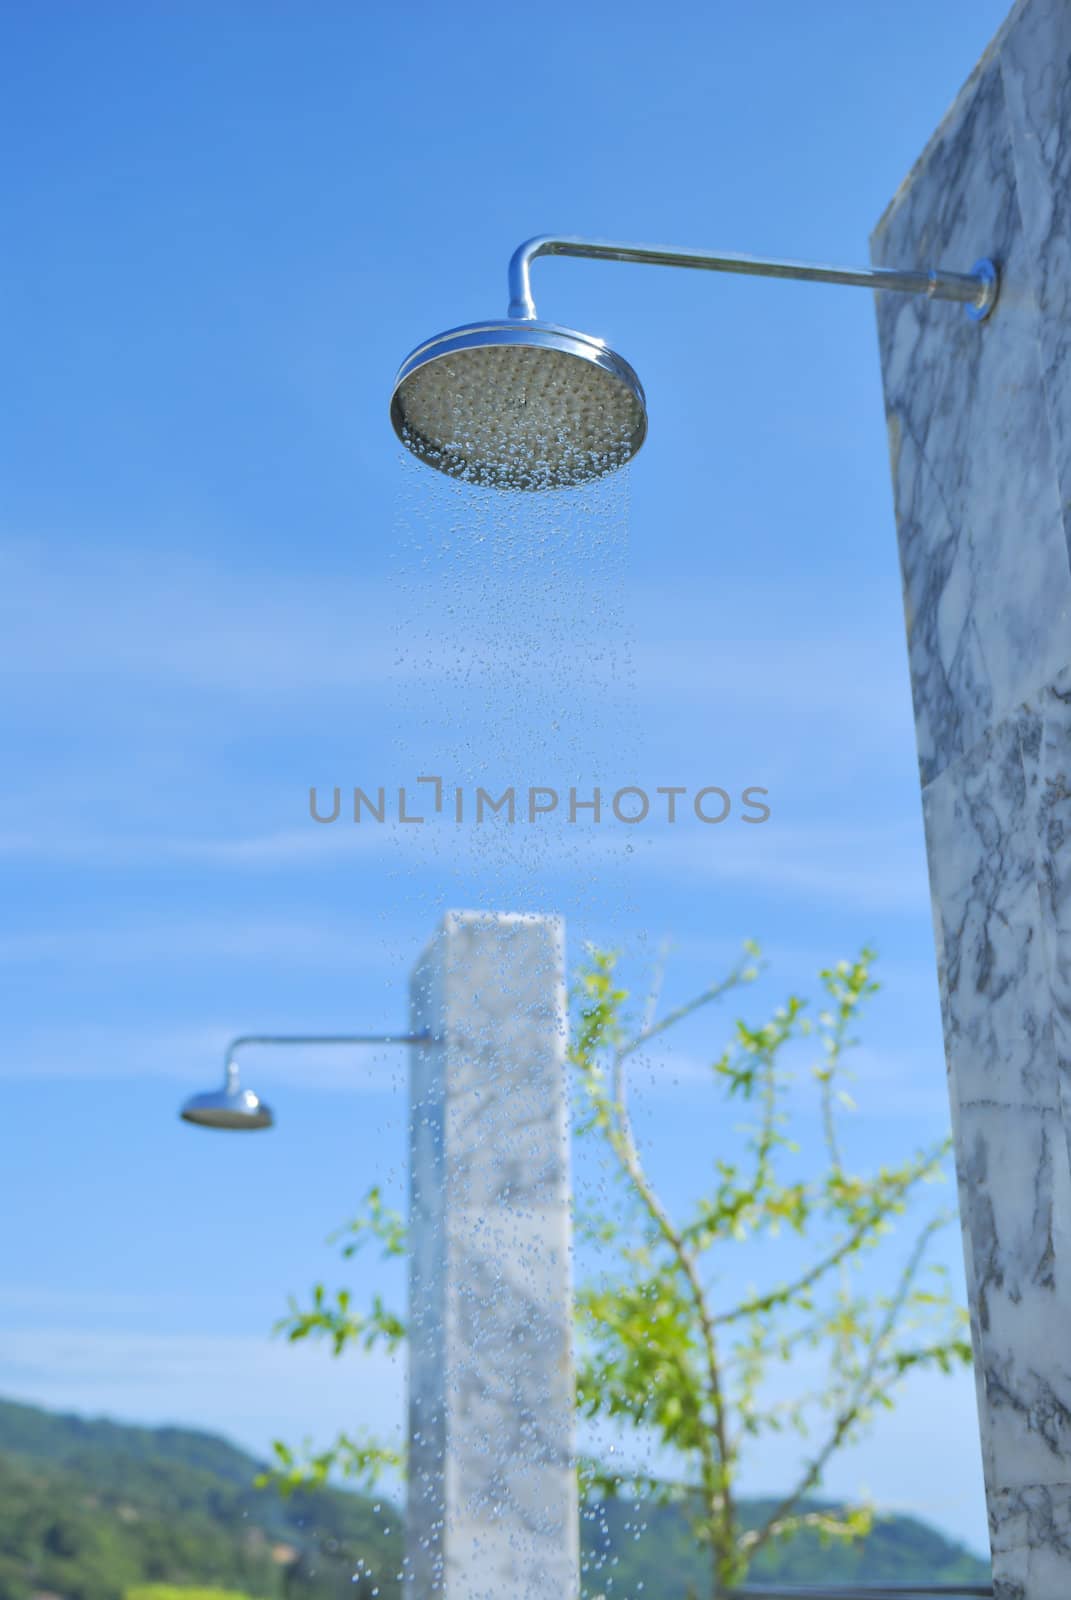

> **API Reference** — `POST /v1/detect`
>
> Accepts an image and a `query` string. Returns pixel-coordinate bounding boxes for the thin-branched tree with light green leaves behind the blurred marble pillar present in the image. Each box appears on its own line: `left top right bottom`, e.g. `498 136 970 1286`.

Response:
266 944 972 1597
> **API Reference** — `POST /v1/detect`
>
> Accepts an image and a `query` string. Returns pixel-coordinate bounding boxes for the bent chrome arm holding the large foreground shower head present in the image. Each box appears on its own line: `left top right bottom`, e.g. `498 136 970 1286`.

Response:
509 234 999 322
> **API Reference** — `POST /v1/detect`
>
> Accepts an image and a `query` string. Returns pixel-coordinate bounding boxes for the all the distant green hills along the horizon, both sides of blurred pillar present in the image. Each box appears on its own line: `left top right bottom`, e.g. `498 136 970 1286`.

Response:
0 1400 989 1600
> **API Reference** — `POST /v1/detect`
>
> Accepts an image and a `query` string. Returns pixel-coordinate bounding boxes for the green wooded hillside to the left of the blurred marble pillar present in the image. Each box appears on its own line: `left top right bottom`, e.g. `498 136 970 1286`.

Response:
0 1400 402 1600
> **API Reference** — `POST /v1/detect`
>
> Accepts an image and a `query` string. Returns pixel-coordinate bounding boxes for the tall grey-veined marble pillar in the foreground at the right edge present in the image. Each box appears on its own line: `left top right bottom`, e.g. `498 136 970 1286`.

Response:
871 0 1071 1600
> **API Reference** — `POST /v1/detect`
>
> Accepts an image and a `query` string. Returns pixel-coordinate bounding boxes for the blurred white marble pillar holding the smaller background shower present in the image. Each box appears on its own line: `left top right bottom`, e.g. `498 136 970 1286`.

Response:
407 912 580 1600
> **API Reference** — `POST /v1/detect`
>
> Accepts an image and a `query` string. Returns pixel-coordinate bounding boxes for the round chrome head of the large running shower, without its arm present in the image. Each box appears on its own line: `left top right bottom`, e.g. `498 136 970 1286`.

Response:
391 320 647 490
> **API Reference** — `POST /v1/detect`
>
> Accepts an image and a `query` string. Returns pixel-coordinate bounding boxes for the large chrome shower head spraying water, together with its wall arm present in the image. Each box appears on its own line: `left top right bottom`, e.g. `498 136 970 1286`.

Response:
391 234 1001 490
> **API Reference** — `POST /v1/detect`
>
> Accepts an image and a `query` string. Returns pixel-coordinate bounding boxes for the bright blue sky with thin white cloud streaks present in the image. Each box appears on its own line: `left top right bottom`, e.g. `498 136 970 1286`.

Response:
0 0 1005 1568
